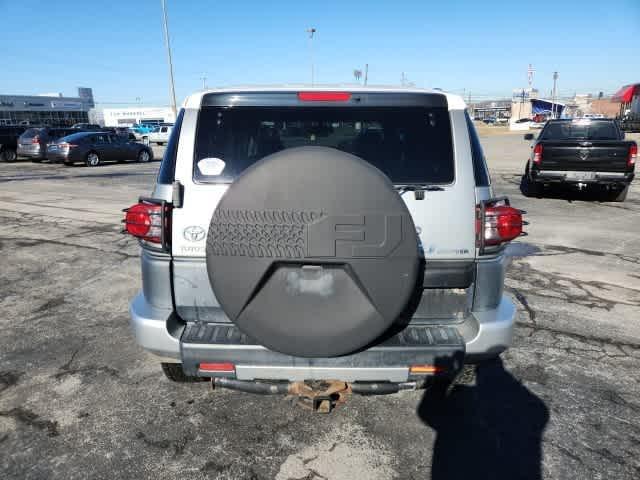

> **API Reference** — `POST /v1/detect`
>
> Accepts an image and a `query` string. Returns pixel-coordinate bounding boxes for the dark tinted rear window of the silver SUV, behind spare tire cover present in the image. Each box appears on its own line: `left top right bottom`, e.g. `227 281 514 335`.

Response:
194 107 454 184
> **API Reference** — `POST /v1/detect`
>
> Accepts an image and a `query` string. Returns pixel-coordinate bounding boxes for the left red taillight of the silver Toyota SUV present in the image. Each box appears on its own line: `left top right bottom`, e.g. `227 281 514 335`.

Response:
124 201 170 247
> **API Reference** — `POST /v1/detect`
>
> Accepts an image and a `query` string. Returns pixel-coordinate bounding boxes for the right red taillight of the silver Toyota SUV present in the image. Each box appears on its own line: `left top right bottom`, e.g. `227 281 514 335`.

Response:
476 200 526 253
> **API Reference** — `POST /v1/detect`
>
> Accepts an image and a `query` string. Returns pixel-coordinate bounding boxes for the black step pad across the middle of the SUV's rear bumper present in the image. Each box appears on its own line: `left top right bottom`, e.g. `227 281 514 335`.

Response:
180 322 465 375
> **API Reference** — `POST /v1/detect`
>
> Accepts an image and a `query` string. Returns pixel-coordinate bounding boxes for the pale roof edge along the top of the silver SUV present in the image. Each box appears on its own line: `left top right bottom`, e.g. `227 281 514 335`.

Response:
182 84 466 110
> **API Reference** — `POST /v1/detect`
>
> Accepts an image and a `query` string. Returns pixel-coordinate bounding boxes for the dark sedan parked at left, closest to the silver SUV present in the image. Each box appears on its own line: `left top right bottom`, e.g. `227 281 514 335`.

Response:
47 132 153 167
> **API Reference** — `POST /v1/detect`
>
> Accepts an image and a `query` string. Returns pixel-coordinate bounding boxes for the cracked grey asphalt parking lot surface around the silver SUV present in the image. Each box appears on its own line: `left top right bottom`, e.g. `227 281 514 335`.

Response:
0 134 640 480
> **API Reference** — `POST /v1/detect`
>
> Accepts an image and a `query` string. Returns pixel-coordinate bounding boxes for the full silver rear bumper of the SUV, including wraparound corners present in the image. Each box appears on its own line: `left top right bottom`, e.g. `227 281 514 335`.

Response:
130 292 516 382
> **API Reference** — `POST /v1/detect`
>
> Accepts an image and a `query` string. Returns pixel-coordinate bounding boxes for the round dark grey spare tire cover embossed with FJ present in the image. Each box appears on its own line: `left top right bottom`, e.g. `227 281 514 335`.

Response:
206 147 419 357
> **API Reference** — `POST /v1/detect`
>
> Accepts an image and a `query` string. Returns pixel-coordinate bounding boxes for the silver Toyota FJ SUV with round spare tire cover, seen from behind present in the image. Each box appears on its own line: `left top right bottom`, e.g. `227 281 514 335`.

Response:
125 87 522 408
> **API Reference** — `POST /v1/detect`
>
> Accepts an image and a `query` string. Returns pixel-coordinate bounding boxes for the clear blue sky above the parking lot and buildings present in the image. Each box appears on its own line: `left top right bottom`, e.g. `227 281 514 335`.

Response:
0 0 640 106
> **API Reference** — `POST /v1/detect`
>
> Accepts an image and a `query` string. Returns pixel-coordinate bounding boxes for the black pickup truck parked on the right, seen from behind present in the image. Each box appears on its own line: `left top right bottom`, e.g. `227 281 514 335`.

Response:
522 119 638 202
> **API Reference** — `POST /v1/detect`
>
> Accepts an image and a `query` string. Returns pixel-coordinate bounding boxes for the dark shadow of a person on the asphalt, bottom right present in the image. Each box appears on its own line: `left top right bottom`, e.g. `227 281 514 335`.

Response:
418 359 549 480
